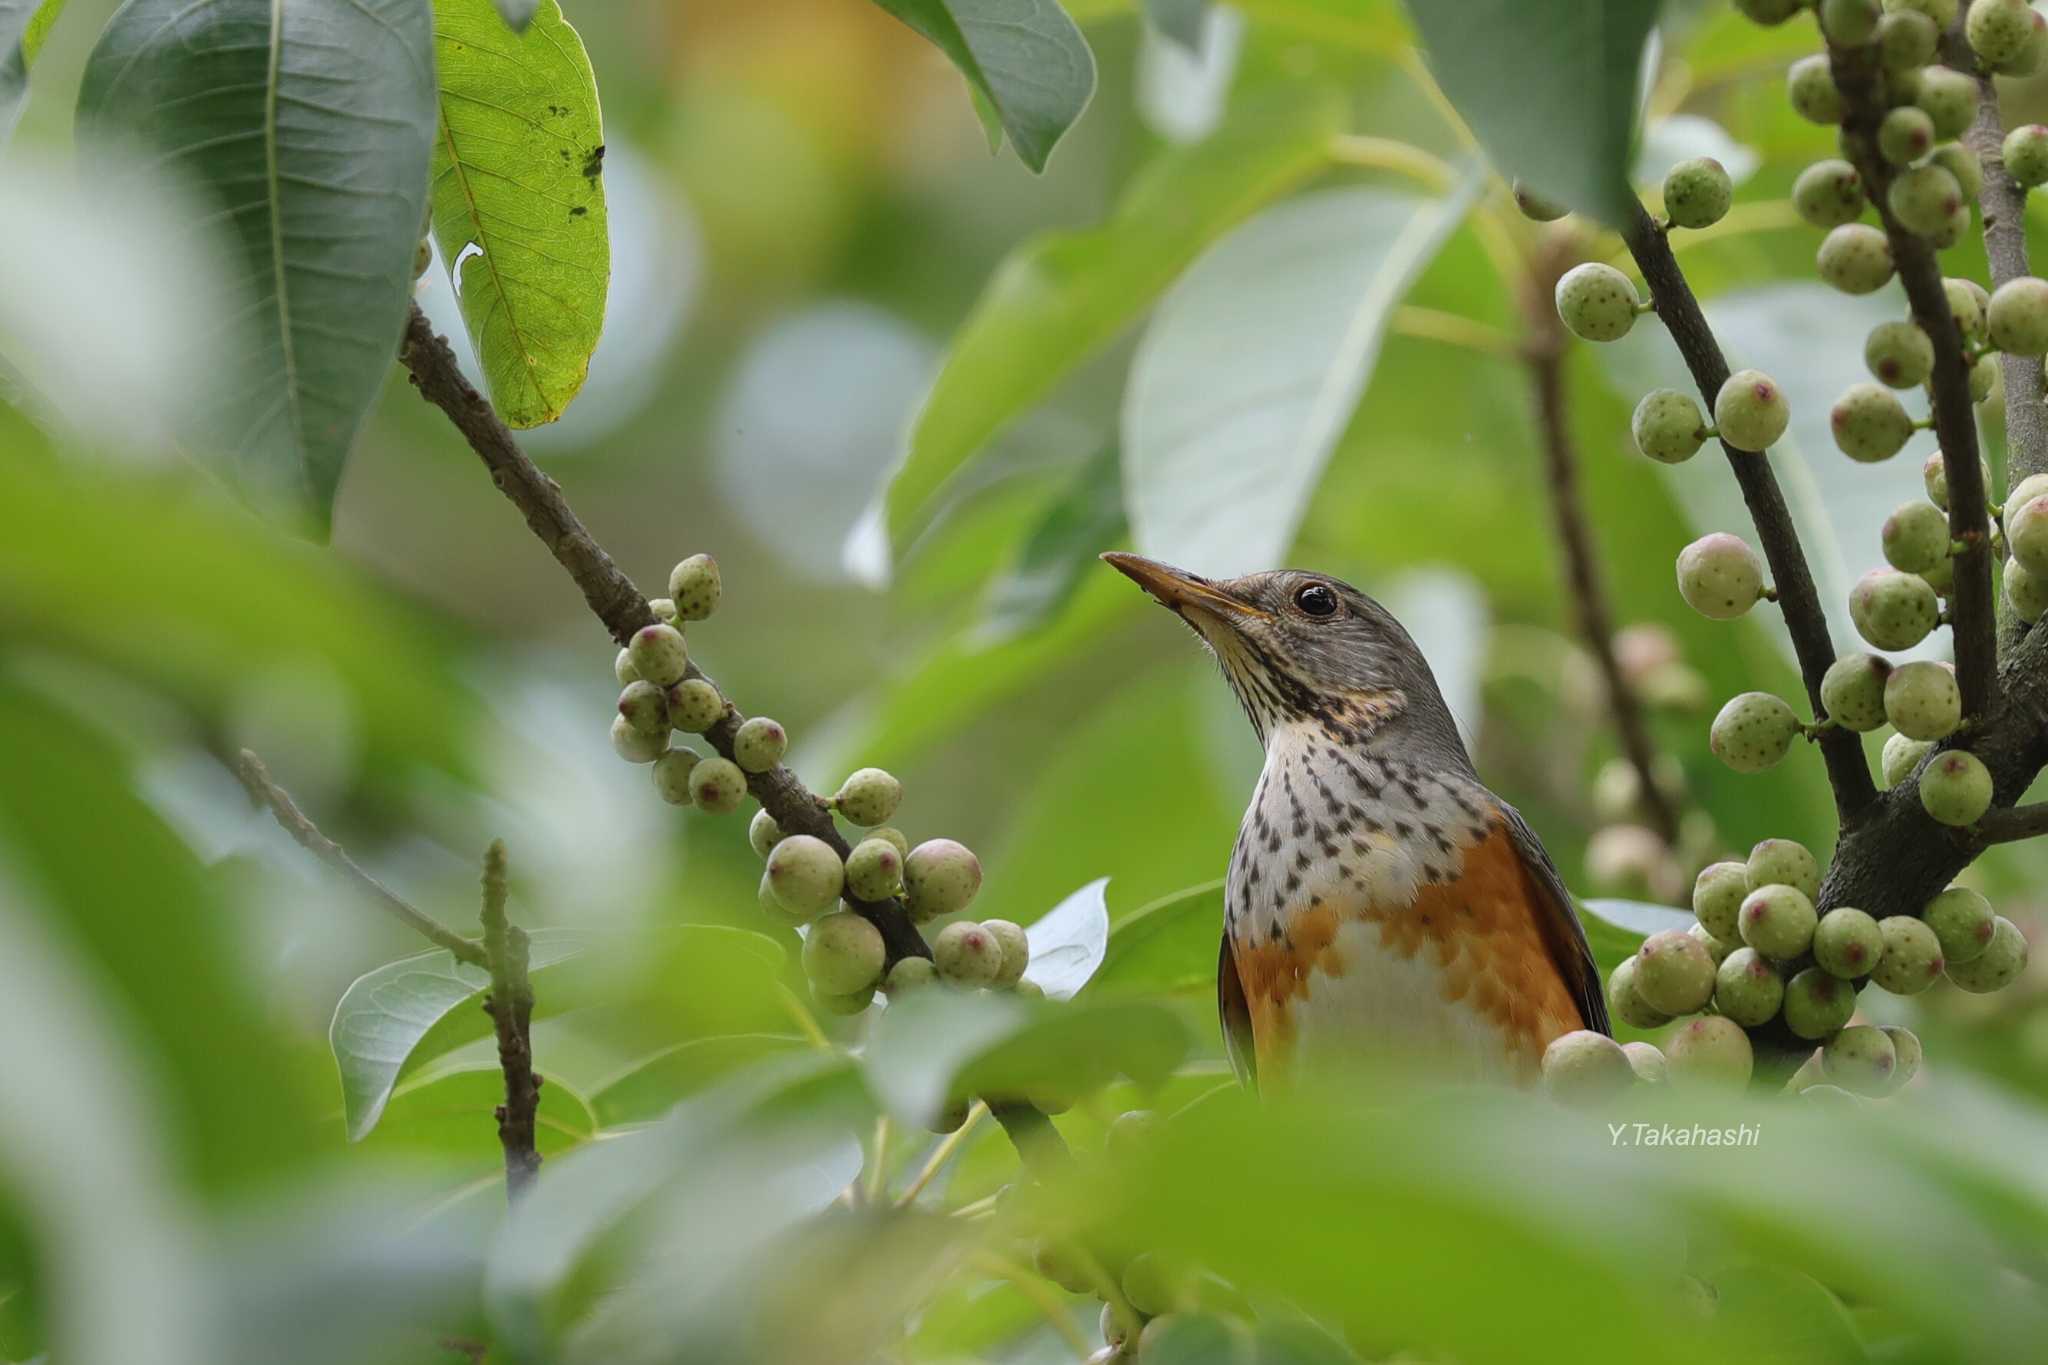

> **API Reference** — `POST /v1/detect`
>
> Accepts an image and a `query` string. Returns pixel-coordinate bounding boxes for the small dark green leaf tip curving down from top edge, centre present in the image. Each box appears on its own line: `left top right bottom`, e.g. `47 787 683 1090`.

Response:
874 0 1096 170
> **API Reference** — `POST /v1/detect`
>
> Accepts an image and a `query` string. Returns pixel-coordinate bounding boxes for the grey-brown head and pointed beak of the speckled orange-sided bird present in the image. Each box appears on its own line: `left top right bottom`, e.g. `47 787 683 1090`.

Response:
1102 555 1462 755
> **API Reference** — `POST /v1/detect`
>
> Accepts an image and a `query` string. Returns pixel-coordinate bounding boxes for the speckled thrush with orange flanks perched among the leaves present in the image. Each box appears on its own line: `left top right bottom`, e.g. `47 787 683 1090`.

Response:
1102 553 1610 1091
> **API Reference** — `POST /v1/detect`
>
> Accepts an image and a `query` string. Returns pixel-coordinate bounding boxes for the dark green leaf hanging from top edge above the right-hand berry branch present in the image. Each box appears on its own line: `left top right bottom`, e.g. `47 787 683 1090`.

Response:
1407 0 1661 225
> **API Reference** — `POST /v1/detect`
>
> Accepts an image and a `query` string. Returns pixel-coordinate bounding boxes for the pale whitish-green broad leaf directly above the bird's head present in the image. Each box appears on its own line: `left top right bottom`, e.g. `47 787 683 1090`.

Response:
1122 176 1479 575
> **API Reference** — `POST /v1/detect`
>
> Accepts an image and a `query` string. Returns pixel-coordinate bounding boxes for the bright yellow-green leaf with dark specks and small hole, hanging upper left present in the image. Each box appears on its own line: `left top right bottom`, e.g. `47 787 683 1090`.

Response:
421 0 612 428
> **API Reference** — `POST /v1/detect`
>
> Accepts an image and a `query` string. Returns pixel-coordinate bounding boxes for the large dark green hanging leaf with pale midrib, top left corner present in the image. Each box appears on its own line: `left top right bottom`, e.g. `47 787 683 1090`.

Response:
78 0 434 534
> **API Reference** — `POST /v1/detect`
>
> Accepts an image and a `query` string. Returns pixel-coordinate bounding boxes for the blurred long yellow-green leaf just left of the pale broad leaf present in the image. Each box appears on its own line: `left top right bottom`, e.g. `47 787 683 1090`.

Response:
885 90 1343 553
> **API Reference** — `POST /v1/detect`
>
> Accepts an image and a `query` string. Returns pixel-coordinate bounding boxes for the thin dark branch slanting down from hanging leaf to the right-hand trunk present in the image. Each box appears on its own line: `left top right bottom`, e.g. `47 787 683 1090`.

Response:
1622 205 1878 829
